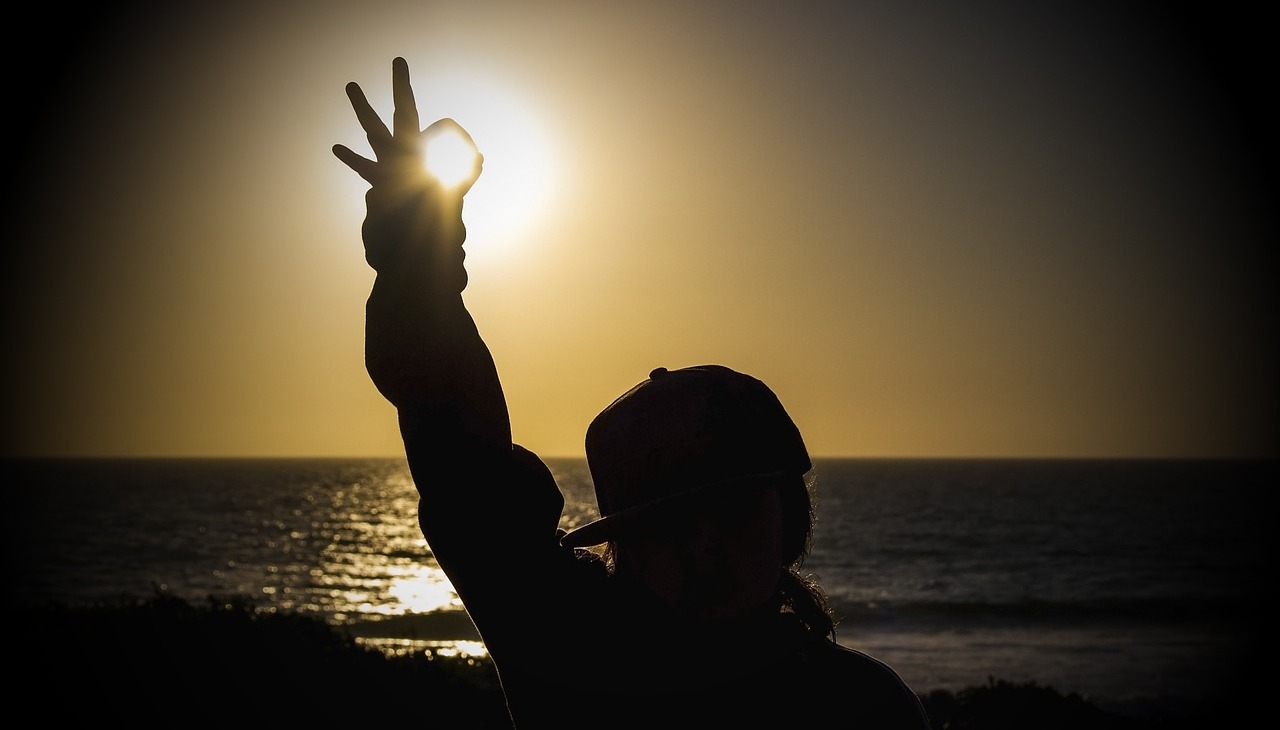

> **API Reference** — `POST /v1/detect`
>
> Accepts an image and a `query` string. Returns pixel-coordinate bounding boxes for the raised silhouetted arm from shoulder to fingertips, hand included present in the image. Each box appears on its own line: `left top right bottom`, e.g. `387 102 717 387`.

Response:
333 59 576 648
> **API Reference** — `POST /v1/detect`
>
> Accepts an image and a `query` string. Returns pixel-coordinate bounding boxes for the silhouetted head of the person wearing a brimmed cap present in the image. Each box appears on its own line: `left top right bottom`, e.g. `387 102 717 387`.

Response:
562 365 829 629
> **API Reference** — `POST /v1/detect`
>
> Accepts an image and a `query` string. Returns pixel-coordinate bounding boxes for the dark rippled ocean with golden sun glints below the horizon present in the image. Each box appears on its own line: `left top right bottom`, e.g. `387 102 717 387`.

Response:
3 458 1277 711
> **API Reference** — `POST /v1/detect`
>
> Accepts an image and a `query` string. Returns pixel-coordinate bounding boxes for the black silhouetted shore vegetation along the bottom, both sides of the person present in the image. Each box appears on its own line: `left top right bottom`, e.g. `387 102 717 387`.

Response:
6 594 1265 730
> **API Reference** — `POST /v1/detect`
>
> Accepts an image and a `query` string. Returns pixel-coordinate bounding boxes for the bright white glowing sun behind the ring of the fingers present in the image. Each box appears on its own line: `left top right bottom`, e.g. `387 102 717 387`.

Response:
413 73 558 248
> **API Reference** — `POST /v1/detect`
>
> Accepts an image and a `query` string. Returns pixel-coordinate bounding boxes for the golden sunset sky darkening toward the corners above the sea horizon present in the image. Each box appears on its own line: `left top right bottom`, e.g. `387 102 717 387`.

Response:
0 0 1280 457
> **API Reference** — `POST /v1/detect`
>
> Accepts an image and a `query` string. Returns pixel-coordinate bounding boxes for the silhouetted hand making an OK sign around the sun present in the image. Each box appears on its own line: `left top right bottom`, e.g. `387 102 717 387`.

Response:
333 58 484 197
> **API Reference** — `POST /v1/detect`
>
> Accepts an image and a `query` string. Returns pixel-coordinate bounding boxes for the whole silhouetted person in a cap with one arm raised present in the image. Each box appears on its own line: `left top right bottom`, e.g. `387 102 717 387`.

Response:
333 59 929 730
